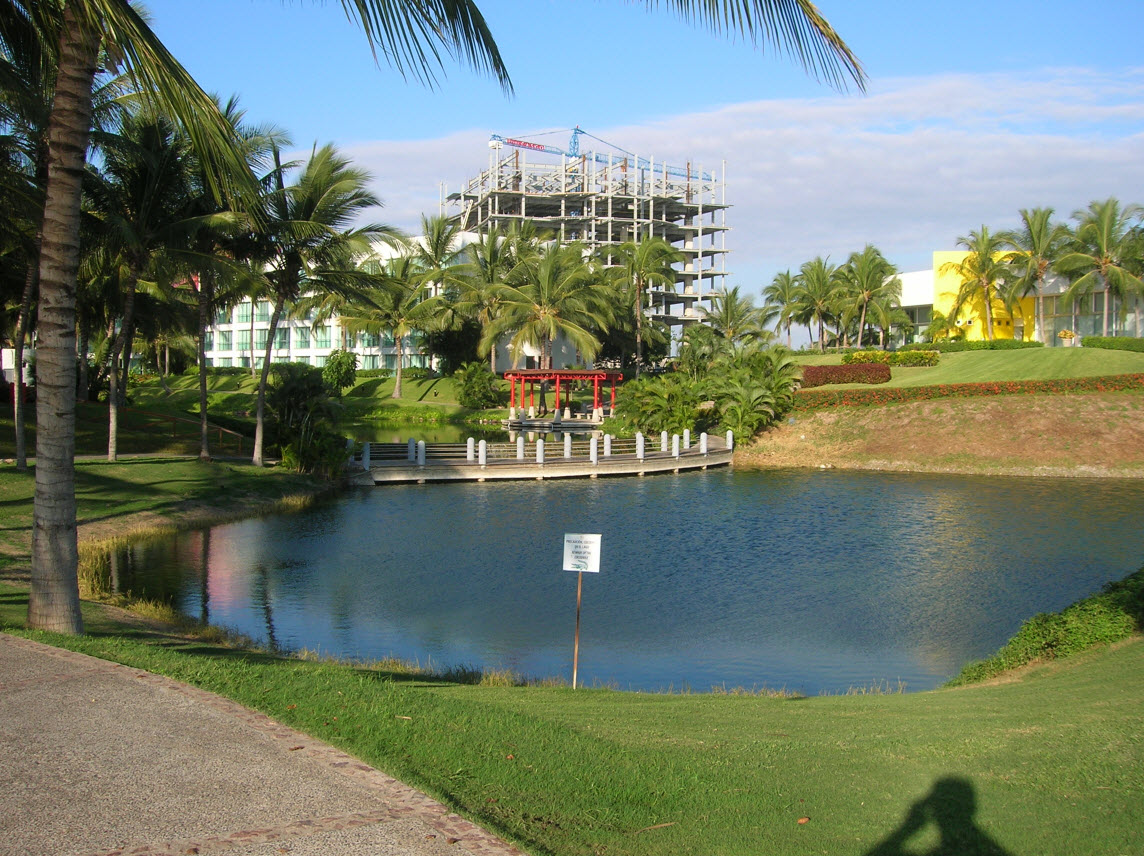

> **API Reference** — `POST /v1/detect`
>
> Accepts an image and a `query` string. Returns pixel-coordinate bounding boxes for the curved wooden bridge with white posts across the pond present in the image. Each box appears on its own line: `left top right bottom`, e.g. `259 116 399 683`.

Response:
349 434 733 484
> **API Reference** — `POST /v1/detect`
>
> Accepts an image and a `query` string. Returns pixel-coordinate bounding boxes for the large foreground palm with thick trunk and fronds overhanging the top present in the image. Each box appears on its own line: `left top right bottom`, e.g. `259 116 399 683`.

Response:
22 0 865 633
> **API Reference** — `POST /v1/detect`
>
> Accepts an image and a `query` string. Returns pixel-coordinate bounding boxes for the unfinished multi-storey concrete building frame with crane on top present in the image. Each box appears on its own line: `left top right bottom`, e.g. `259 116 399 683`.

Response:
447 128 728 326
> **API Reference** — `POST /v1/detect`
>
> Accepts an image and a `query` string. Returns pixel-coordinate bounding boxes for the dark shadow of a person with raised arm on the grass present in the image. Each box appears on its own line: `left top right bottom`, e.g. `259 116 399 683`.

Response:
864 776 1012 856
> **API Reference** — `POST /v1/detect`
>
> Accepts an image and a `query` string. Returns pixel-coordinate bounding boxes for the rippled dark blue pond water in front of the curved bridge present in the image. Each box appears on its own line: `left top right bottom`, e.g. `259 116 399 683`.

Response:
116 469 1144 693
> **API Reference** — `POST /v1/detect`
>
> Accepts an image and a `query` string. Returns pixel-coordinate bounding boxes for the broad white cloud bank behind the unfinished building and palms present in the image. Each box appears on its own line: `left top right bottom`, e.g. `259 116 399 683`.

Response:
336 69 1144 291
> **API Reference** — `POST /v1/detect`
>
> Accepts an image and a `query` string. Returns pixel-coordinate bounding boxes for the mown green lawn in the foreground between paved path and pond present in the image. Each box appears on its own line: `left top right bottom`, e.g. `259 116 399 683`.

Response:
0 591 1144 856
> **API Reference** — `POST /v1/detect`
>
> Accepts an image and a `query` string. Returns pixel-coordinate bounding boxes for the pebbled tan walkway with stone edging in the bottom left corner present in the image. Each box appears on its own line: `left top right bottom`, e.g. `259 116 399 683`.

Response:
0 633 522 856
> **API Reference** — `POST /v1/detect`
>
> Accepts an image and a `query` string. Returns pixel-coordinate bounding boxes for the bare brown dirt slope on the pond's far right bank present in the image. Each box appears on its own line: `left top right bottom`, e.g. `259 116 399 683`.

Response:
734 393 1144 478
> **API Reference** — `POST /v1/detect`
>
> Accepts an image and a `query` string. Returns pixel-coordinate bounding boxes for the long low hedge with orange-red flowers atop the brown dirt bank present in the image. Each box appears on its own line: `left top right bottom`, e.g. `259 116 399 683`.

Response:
794 366 1144 411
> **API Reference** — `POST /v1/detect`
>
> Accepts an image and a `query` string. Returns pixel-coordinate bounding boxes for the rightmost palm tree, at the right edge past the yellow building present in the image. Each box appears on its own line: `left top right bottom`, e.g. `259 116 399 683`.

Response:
1056 198 1144 335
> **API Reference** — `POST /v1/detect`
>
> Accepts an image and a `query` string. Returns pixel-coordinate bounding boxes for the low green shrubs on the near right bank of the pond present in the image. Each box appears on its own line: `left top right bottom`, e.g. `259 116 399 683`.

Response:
948 568 1144 687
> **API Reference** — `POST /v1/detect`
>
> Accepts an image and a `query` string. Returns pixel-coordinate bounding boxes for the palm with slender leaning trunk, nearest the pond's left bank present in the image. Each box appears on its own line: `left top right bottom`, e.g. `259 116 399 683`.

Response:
253 145 394 466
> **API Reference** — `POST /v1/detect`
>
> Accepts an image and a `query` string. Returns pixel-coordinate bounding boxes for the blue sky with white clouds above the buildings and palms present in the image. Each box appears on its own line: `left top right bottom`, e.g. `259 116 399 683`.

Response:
144 0 1144 294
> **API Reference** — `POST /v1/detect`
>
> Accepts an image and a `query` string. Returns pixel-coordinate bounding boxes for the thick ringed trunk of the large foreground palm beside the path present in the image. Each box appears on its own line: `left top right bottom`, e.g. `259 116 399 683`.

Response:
27 3 100 634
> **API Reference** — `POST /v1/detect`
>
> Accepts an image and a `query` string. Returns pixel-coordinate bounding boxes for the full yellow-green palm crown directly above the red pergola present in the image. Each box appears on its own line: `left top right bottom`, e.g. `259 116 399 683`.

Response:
482 244 610 368
